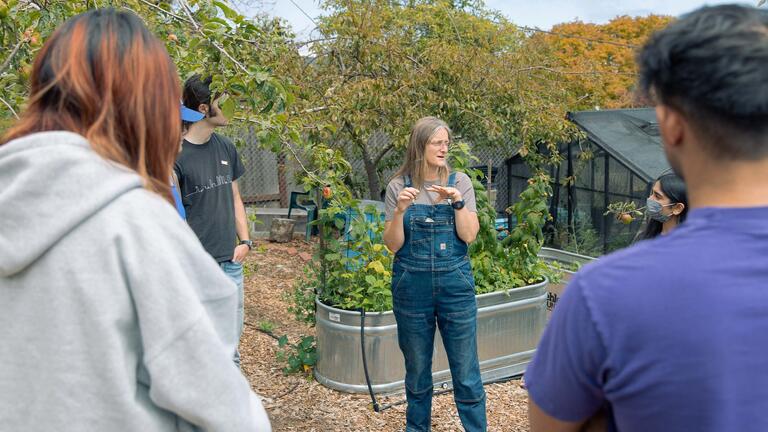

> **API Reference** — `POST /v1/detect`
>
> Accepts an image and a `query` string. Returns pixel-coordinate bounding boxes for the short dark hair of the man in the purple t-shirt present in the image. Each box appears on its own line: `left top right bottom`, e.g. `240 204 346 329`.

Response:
638 5 768 160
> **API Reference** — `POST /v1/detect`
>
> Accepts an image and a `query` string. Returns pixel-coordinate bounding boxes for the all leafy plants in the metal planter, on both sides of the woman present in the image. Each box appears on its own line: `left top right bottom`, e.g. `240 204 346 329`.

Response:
290 142 559 322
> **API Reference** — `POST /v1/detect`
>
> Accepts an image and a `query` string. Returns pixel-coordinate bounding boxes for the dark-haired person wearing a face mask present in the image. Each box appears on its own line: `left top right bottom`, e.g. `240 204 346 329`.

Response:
636 173 688 241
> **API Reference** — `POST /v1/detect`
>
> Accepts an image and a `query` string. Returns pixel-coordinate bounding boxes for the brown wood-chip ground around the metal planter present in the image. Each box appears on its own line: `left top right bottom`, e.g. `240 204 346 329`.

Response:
240 240 528 432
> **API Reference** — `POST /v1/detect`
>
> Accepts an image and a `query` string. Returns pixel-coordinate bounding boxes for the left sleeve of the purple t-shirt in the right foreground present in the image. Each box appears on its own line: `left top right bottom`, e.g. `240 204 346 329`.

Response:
525 275 606 422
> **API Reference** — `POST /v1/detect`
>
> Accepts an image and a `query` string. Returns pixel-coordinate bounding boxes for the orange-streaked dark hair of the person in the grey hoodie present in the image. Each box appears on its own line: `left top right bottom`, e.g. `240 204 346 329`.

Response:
2 8 181 201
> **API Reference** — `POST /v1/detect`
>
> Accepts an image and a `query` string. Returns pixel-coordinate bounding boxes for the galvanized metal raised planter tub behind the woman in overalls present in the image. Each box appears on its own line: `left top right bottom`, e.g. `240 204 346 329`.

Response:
315 281 547 394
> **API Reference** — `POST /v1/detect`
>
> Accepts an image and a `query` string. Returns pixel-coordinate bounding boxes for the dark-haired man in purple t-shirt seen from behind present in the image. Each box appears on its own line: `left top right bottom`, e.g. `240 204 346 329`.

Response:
525 5 768 432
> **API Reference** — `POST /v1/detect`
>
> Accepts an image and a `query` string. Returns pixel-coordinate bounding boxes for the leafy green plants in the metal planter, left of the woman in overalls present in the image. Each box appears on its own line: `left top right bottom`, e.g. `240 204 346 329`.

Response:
290 140 392 316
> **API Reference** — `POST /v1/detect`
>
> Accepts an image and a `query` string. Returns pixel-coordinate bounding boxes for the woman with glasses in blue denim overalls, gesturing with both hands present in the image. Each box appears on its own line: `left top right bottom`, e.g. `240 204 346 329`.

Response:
384 117 486 432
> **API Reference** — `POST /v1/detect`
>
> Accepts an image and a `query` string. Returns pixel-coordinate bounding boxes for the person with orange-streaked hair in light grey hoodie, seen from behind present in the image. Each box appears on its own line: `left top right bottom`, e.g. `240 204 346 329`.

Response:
0 9 271 432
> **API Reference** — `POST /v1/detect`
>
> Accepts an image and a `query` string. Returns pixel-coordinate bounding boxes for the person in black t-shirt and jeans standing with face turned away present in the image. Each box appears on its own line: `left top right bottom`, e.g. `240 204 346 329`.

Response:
174 75 251 366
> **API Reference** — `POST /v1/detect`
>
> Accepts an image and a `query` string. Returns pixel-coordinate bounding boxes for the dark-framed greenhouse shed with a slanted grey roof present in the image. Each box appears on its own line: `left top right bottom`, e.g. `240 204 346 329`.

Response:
504 108 670 256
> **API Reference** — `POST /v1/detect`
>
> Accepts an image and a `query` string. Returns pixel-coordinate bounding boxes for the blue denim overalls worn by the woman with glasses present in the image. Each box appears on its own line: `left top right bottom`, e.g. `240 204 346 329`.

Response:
392 174 486 432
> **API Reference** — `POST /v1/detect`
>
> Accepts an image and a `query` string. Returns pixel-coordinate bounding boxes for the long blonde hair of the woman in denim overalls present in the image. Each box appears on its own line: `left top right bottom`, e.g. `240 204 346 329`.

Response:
393 117 453 189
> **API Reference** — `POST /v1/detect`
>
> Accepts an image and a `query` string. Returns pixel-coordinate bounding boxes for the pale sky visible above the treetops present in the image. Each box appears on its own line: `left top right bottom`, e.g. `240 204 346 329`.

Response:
248 0 756 39
